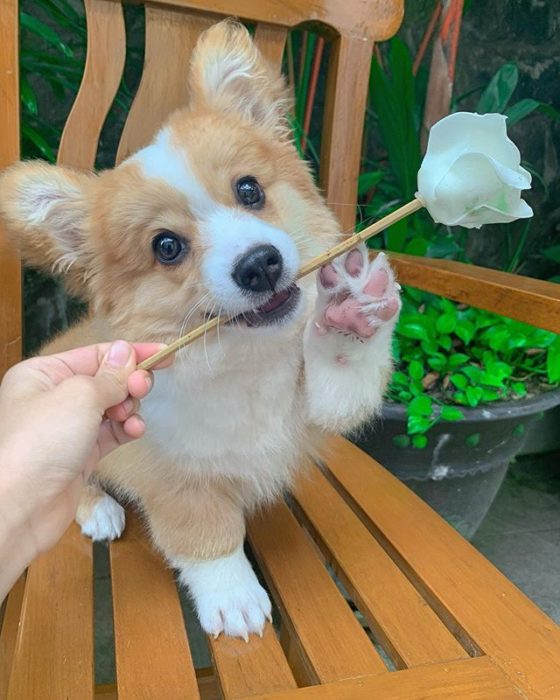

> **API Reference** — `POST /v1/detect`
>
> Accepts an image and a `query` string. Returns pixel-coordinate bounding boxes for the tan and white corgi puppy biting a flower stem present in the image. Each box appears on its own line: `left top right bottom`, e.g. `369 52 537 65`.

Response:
0 21 400 639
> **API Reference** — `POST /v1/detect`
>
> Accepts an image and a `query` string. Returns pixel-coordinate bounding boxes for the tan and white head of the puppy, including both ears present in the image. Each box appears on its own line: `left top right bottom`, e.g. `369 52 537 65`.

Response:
0 22 337 340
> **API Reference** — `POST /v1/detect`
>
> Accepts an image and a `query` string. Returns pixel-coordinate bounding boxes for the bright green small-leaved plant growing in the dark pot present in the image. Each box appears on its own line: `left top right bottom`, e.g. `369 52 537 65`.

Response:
387 289 560 448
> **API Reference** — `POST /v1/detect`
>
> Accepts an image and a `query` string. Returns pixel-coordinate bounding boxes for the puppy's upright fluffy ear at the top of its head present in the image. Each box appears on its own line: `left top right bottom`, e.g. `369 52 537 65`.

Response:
189 20 289 134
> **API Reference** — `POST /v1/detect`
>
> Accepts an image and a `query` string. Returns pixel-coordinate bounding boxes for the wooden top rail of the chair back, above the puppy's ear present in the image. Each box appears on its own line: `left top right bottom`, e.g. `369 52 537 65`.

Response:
130 0 404 41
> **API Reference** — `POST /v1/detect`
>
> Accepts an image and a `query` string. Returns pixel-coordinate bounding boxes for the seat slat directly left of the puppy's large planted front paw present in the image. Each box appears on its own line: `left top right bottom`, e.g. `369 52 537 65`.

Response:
110 511 199 700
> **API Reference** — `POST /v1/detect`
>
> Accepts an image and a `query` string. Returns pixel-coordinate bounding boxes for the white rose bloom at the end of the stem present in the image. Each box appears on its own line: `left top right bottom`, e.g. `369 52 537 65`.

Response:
417 112 533 228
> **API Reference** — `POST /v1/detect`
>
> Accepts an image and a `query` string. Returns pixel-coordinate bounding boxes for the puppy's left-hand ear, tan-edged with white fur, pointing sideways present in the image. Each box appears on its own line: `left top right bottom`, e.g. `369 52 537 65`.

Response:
0 161 95 292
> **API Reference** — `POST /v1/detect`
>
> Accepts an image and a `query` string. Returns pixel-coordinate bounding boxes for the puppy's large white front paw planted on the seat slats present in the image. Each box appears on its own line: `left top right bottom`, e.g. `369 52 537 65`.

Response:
173 547 272 642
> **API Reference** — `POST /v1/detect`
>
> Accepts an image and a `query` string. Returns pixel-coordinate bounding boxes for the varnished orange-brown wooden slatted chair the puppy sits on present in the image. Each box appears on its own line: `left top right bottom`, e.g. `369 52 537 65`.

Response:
0 0 560 700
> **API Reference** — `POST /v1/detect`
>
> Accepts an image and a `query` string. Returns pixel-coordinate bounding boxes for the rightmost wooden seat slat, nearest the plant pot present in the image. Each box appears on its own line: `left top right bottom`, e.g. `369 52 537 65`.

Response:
325 438 560 699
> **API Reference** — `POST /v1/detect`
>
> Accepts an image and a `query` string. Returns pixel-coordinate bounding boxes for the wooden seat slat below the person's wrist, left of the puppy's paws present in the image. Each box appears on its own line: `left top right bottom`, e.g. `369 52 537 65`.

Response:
7 523 93 700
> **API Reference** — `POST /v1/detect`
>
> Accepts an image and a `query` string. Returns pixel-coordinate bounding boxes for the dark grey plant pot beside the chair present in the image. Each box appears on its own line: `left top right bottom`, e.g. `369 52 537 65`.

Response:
352 389 560 538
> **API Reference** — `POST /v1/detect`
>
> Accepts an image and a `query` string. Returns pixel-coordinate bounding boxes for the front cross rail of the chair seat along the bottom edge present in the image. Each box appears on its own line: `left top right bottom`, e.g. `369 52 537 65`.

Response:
251 658 520 700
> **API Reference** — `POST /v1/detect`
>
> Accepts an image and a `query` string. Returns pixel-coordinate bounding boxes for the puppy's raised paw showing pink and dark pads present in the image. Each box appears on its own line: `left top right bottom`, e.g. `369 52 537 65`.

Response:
315 244 401 339
